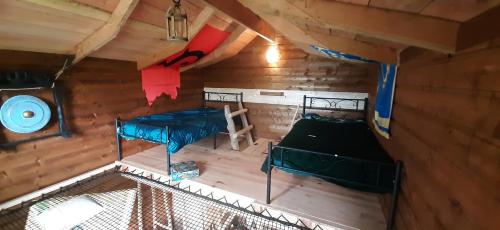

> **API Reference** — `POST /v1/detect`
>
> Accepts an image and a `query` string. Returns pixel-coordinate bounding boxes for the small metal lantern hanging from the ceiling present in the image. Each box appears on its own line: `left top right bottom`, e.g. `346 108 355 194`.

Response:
165 0 188 41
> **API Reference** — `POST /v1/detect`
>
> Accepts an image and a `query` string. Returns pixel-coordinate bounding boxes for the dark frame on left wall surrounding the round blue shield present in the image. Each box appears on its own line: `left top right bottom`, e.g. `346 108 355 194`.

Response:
0 71 71 149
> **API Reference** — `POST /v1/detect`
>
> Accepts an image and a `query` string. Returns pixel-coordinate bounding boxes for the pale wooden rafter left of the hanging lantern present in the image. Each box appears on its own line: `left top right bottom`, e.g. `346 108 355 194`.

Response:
73 0 139 64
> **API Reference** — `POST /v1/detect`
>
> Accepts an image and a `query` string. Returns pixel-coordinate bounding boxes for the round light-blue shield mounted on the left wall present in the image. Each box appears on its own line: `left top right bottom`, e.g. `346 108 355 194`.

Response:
0 95 51 133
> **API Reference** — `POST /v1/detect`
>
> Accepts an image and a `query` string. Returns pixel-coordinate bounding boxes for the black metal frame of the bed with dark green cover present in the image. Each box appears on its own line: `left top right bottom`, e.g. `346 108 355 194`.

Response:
266 95 402 229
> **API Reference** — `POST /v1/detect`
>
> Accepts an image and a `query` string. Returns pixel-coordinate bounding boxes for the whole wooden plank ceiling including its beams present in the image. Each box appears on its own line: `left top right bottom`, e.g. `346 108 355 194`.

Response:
0 0 500 69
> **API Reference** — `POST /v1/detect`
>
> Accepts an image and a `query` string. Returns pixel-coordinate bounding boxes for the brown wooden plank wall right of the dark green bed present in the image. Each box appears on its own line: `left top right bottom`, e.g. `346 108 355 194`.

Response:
370 42 500 229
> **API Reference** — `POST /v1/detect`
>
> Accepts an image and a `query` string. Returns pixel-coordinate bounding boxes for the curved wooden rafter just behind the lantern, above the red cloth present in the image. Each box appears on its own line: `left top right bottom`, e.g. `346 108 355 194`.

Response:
137 7 214 70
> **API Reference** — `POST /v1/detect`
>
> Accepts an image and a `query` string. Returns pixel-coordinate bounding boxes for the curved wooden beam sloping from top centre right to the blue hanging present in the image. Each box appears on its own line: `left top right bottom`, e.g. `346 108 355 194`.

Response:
234 0 398 64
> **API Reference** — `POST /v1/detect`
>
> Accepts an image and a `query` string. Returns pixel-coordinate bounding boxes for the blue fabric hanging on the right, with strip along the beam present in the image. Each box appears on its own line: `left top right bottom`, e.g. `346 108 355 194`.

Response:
311 45 398 139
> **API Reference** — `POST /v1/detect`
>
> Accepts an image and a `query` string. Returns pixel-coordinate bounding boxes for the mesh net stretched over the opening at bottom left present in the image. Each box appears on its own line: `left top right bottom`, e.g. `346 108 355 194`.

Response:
0 170 309 230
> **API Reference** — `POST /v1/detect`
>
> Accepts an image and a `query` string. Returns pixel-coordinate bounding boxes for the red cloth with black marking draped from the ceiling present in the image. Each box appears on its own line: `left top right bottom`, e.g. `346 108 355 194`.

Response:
141 25 229 106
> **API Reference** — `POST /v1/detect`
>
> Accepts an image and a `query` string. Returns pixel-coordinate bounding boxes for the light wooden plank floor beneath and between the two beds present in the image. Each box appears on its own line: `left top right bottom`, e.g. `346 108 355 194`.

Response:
123 136 385 229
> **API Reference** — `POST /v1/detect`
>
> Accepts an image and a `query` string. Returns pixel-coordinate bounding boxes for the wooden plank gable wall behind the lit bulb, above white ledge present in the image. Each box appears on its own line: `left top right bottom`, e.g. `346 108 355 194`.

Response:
203 37 373 92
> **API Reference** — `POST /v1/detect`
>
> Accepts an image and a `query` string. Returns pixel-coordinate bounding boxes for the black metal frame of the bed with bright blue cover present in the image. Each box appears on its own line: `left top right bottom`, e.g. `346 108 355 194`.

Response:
115 91 243 175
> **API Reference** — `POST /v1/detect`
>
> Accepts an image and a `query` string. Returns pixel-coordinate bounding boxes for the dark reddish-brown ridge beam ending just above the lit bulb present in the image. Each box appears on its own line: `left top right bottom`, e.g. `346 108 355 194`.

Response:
203 0 276 42
